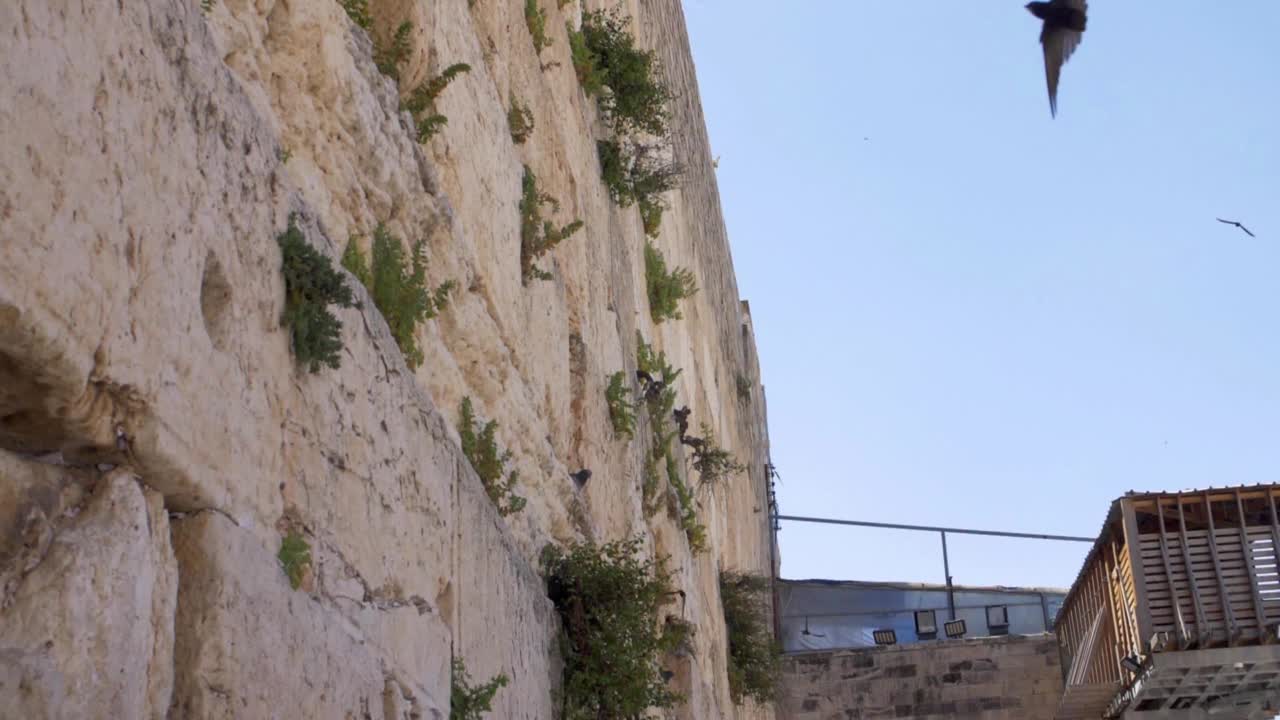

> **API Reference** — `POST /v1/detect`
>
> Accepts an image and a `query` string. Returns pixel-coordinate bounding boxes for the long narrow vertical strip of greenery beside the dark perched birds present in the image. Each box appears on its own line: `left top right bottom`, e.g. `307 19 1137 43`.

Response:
636 332 707 552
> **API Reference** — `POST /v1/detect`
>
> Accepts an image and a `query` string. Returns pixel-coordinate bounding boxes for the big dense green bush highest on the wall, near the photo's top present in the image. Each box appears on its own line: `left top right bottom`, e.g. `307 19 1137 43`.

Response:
571 10 672 137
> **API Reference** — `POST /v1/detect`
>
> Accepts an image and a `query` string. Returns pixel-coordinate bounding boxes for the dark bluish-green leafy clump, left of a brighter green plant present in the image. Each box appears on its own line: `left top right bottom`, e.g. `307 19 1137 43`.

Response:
276 215 353 373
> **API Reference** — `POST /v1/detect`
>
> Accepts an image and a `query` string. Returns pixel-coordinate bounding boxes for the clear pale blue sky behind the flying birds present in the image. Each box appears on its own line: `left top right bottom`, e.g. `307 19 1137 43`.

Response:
685 0 1280 587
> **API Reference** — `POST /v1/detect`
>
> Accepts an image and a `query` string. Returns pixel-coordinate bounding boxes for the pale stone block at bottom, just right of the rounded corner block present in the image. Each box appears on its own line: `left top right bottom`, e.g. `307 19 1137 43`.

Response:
172 511 449 719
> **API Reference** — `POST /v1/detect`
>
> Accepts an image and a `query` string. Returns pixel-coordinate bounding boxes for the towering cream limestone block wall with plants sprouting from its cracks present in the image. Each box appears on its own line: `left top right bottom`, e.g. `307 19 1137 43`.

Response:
0 0 772 719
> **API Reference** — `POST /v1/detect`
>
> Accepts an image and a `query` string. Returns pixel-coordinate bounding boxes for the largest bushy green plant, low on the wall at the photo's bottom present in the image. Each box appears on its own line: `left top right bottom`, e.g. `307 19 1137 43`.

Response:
541 538 689 720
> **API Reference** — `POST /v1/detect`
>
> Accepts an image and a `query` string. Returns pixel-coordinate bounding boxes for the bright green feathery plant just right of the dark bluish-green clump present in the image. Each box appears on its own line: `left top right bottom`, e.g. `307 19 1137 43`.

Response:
342 223 456 369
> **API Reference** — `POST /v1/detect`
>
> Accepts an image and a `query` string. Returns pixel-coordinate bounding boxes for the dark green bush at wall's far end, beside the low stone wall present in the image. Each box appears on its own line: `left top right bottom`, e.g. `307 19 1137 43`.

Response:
719 571 782 703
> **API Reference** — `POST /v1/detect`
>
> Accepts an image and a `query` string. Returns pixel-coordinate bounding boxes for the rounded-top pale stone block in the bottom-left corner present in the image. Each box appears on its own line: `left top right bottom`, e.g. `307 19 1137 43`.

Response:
0 468 178 720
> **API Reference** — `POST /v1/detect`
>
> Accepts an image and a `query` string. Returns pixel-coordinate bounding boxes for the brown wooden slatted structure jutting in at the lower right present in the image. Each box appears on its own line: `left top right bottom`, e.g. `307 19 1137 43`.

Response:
1055 486 1280 720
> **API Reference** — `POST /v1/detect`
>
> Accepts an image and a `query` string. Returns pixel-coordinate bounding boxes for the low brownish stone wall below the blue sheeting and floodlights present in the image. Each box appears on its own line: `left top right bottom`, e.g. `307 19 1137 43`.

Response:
778 635 1062 720
